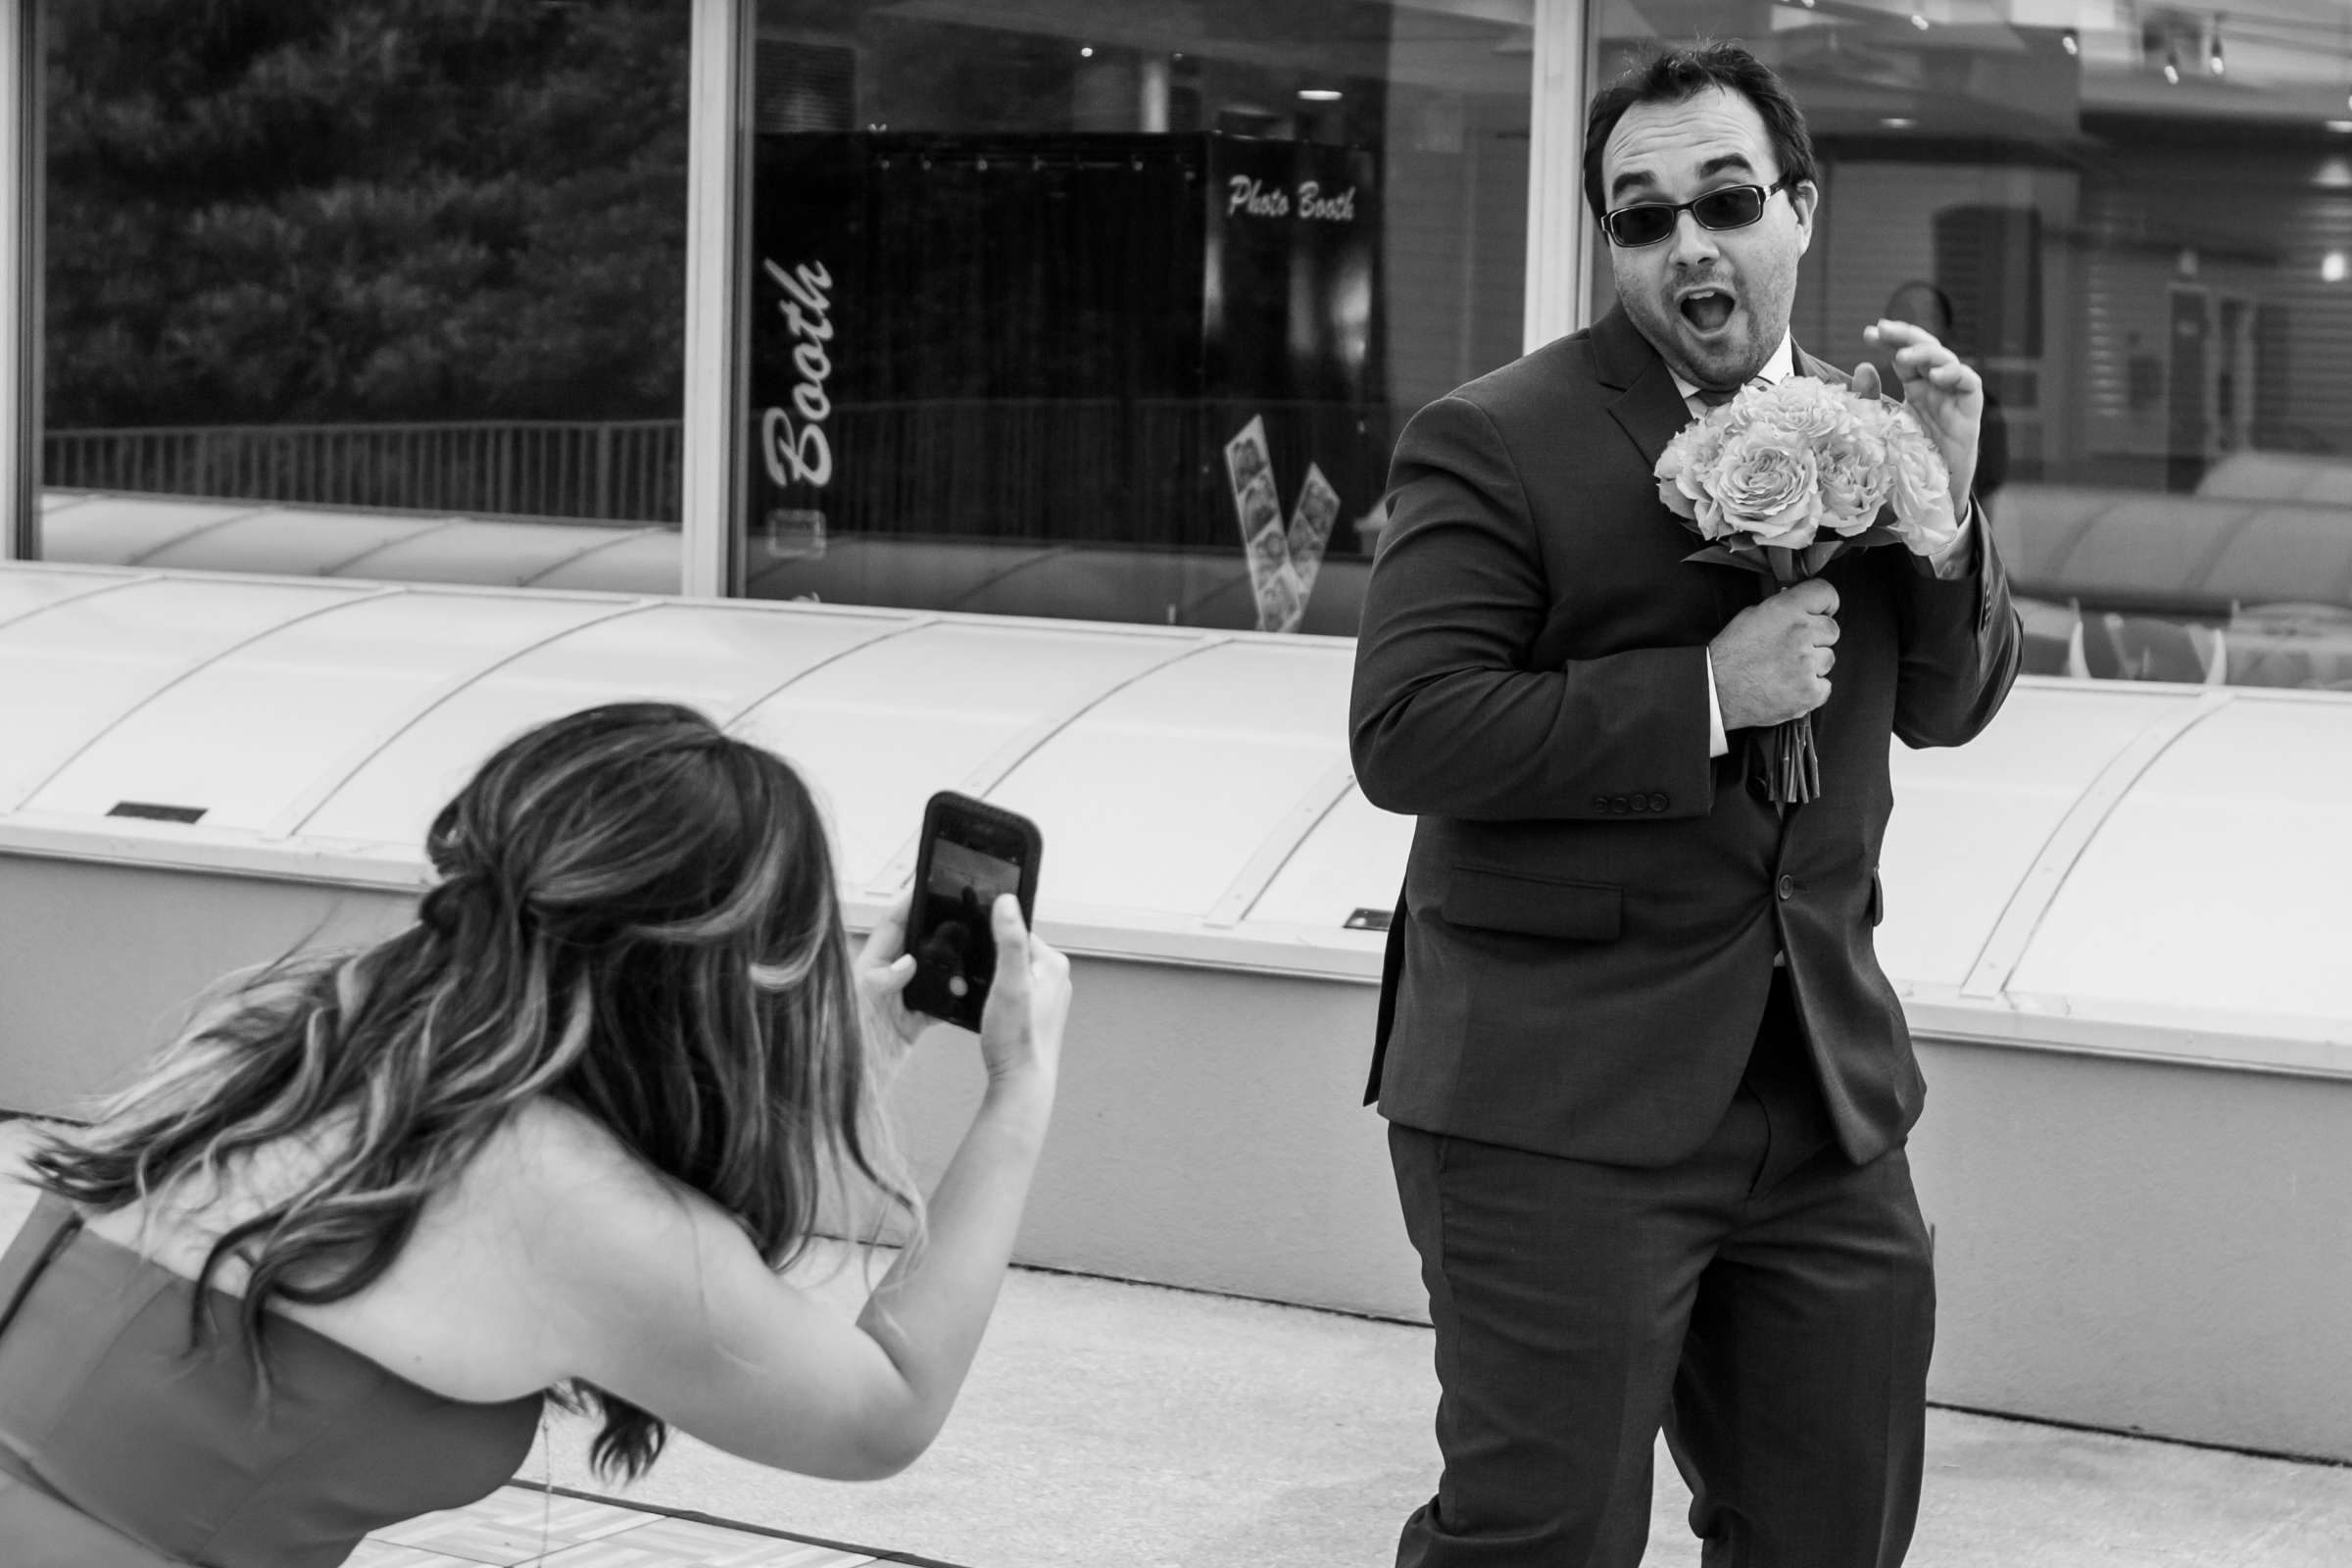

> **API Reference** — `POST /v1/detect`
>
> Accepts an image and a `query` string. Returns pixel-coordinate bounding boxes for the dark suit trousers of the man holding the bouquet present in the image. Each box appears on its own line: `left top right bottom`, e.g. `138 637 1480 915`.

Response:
1390 976 1936 1568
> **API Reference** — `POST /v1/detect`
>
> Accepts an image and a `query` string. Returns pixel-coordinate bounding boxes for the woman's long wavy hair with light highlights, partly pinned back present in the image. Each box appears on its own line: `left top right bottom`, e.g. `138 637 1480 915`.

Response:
30 703 915 1474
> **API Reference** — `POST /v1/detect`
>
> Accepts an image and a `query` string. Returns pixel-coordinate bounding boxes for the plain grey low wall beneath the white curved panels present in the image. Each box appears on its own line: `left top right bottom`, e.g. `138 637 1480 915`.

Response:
0 856 2352 1460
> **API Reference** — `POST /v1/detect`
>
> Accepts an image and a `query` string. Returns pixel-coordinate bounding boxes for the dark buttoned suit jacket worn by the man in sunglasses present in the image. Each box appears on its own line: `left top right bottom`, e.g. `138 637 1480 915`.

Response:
1350 311 2021 1166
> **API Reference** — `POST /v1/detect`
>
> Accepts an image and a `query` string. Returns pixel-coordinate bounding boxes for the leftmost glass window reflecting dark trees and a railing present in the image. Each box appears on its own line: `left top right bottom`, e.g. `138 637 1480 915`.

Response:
42 0 687 590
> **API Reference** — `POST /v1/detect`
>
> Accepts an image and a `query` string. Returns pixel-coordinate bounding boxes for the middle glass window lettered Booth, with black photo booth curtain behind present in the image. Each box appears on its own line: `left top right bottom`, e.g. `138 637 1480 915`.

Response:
741 0 1531 635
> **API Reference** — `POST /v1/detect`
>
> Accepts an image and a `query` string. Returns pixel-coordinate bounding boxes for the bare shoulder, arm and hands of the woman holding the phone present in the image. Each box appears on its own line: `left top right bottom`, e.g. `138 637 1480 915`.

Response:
508 898 1070 1481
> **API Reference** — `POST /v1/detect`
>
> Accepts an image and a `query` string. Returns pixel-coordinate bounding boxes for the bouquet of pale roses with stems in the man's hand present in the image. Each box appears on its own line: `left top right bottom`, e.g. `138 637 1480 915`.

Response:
1656 376 1959 804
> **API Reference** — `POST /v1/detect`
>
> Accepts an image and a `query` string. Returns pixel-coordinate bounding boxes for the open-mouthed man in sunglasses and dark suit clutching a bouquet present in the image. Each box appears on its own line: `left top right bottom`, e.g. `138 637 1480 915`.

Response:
1350 47 2018 1568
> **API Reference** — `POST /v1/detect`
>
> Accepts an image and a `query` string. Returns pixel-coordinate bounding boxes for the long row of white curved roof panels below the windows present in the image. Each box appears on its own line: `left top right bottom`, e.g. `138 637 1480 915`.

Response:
14 562 2352 1074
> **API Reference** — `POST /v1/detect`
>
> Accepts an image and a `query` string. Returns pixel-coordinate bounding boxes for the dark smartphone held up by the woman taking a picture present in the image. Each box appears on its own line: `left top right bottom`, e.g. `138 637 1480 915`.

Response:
906 790 1045 1030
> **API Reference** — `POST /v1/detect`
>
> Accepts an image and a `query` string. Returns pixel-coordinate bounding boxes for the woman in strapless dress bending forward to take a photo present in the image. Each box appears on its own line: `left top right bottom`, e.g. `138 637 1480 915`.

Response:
0 703 1070 1568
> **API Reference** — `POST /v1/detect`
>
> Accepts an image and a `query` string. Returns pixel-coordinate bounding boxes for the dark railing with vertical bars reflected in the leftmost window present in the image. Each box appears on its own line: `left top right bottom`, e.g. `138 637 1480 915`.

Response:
42 418 682 524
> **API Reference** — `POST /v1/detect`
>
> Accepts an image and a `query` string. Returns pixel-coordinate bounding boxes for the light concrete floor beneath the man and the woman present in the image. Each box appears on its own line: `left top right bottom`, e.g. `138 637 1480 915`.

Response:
0 1128 2352 1568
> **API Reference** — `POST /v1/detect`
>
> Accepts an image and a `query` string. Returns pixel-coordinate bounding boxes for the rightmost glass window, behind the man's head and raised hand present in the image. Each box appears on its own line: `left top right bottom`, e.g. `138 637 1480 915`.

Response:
1594 0 2352 686
